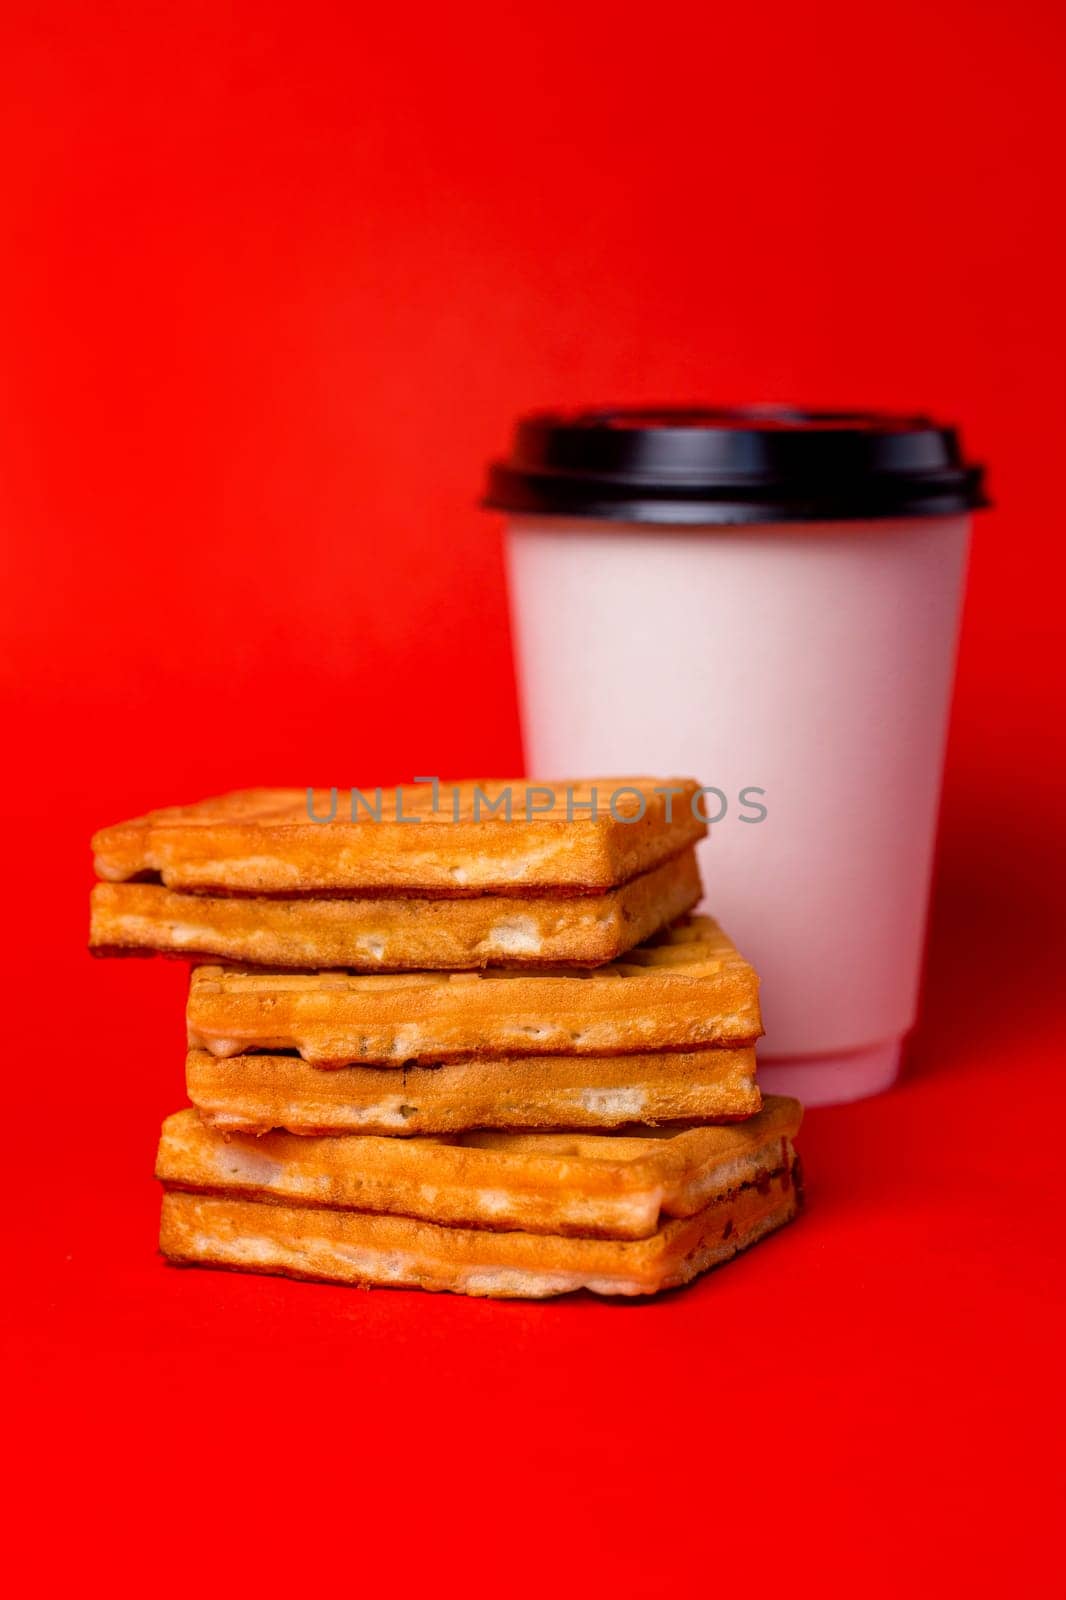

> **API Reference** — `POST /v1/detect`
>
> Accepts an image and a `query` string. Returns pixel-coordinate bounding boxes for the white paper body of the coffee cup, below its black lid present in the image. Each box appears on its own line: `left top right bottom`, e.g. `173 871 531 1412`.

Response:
486 406 980 1104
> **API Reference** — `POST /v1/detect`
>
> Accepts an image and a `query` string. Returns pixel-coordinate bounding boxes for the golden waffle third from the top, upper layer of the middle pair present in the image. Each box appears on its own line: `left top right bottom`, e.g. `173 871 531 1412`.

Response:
187 917 762 1067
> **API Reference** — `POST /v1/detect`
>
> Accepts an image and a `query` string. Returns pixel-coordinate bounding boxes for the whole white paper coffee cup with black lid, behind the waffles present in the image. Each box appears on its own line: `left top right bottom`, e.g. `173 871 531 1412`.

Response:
487 408 986 1104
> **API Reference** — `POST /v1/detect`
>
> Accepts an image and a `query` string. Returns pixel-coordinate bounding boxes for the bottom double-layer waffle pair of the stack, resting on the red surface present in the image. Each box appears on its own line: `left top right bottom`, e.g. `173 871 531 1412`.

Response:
157 1098 802 1299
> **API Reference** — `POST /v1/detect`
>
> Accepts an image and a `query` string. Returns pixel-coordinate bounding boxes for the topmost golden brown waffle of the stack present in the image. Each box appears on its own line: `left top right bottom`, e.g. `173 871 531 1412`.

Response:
93 778 706 894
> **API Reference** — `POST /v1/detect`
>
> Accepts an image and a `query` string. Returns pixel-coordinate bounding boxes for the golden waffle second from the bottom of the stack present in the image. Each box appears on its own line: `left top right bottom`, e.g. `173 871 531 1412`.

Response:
155 1096 802 1238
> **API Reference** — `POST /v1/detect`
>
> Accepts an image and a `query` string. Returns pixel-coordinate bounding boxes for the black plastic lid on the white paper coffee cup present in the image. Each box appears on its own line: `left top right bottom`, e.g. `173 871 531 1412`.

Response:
483 406 989 525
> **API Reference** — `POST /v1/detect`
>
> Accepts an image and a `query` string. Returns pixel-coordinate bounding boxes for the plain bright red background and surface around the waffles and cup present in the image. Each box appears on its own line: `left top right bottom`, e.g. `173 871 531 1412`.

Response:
0 0 1066 1595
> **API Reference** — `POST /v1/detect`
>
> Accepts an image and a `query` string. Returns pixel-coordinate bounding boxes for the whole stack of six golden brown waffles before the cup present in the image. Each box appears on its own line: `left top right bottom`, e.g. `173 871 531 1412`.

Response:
91 778 800 1296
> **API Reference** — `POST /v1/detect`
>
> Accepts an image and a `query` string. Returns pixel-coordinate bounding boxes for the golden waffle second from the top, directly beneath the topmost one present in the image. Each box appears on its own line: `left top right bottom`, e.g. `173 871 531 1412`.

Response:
90 850 701 971
